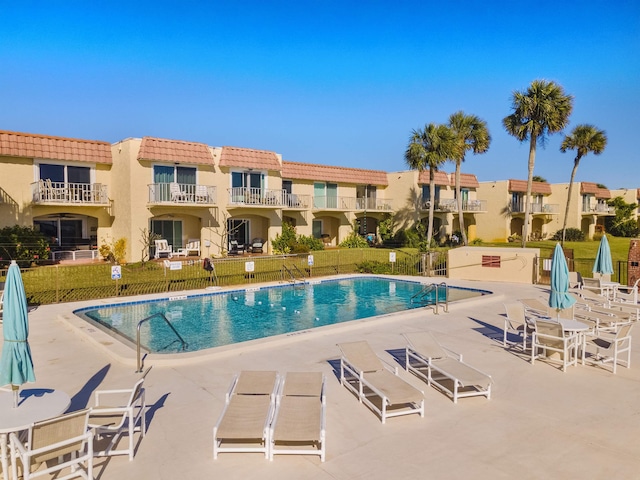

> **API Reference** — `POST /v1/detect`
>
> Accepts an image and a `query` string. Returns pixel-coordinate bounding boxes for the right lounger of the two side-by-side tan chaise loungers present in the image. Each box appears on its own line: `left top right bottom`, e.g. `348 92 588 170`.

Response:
269 372 327 462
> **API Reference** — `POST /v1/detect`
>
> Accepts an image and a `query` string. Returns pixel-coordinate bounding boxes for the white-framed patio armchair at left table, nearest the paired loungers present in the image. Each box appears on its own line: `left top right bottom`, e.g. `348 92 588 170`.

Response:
89 377 147 460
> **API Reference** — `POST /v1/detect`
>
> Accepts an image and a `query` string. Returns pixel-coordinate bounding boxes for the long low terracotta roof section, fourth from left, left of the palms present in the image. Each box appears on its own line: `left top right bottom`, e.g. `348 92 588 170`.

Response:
282 161 389 186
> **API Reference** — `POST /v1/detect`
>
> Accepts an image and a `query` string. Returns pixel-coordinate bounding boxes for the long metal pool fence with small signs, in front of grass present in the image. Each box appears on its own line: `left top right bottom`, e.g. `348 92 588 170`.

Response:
0 248 447 305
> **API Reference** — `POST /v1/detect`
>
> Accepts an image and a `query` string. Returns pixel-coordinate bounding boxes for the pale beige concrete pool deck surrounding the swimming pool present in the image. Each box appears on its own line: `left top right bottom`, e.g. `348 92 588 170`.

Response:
0 277 640 480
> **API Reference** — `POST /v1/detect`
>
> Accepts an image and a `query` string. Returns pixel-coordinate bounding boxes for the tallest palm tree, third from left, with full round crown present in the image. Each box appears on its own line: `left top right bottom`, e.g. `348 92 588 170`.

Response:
502 80 573 248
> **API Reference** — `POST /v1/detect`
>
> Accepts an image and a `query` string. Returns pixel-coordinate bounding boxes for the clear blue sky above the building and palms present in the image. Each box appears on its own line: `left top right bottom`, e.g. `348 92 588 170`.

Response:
0 0 640 188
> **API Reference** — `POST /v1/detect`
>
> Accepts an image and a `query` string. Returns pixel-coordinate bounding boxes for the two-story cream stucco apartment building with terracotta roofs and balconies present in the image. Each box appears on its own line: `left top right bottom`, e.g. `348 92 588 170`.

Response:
0 131 640 261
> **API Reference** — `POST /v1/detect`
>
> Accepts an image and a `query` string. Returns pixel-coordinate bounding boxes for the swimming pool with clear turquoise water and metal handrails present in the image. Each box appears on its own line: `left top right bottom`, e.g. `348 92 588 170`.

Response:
74 277 490 353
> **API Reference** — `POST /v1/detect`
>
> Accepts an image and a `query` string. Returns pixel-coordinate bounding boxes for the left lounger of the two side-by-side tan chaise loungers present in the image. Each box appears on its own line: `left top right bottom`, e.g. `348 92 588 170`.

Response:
213 371 278 459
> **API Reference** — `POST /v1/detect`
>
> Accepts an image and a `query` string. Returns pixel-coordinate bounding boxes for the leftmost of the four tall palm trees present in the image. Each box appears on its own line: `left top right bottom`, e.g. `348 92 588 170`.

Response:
404 123 457 248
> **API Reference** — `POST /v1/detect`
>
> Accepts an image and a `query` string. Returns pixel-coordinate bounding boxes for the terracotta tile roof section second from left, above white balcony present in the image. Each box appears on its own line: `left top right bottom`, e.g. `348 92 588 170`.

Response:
138 137 213 165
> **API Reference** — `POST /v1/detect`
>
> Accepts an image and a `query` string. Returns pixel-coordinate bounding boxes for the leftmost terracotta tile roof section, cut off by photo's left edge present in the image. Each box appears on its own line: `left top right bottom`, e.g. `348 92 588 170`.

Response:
0 130 112 165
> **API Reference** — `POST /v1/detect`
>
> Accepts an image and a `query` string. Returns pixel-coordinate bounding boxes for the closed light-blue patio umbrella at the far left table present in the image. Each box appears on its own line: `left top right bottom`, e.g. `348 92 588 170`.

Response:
0 260 36 407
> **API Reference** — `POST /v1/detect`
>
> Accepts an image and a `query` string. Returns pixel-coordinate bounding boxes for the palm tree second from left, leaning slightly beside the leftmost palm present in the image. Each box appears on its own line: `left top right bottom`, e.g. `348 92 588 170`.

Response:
449 111 491 245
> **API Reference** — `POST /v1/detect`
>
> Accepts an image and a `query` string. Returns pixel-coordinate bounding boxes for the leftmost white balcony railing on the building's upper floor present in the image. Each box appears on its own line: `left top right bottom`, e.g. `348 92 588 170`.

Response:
31 180 109 205
